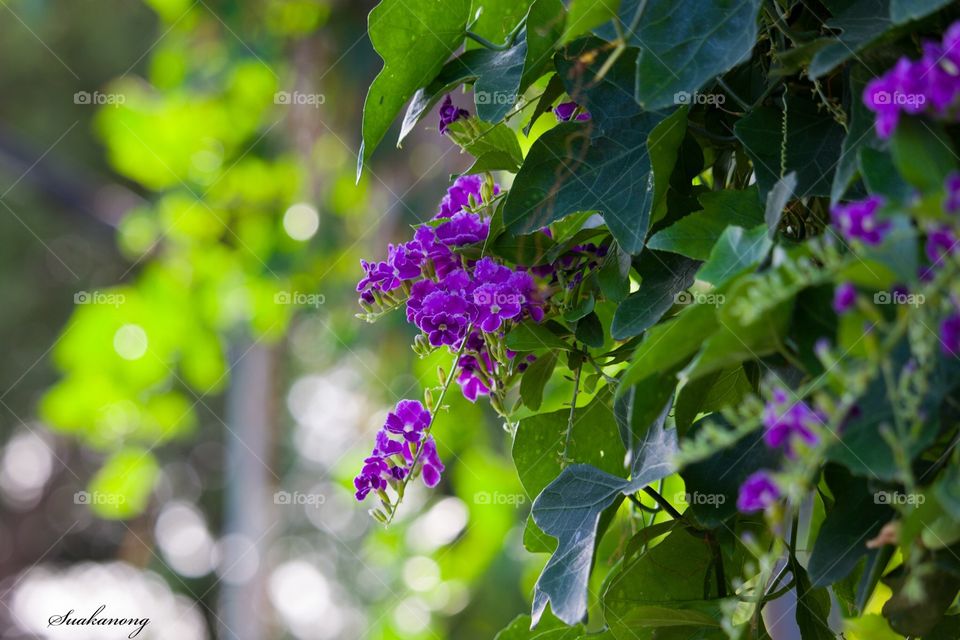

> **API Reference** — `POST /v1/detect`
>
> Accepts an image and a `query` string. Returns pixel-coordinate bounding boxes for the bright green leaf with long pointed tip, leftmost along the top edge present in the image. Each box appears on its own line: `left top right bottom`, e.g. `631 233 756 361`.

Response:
357 0 470 179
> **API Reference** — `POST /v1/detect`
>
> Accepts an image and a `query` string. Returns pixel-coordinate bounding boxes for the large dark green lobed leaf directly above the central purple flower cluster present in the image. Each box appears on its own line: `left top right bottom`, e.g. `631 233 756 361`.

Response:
503 38 663 254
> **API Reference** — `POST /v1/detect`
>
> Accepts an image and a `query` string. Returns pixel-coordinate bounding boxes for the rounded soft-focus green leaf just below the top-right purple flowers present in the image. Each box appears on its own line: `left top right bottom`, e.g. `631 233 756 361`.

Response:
890 118 957 191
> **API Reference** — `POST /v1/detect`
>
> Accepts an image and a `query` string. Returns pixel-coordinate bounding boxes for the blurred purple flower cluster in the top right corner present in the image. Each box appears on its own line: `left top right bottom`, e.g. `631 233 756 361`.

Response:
863 22 960 138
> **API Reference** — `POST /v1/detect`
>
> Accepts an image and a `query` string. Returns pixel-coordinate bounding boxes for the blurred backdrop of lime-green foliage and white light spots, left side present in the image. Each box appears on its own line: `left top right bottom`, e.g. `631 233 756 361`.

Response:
0 0 545 640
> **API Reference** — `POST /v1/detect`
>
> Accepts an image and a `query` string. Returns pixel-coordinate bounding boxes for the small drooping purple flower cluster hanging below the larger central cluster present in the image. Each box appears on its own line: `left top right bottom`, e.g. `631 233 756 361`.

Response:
353 400 443 500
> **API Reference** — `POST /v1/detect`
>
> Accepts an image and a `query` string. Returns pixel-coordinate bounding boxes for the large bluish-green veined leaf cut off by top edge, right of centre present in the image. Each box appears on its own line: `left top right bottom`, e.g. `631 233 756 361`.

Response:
620 0 761 111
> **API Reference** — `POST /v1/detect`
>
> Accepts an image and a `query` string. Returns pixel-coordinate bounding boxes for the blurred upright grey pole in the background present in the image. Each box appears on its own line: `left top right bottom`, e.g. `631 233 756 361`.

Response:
219 340 277 640
